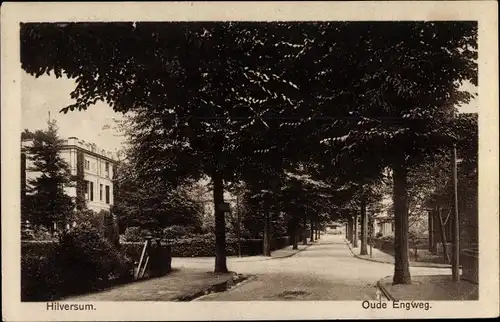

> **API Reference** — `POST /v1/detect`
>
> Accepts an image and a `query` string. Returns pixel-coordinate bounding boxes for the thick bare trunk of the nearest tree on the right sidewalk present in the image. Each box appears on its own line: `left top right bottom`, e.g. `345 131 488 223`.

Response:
393 165 411 284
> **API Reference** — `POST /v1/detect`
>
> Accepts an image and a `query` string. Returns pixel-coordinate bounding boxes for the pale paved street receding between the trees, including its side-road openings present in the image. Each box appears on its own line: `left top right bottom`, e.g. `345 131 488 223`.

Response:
172 235 449 301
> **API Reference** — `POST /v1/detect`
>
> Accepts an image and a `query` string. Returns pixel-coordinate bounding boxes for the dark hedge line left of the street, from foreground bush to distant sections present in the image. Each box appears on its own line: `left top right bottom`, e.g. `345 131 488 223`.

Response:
21 232 290 301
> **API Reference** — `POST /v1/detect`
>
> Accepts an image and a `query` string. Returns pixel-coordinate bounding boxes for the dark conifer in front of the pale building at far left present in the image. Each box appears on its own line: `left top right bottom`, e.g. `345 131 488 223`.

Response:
26 121 74 229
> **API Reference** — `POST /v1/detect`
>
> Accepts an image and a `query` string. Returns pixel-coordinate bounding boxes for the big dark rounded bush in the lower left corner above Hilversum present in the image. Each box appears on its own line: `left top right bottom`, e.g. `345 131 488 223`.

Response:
21 227 133 301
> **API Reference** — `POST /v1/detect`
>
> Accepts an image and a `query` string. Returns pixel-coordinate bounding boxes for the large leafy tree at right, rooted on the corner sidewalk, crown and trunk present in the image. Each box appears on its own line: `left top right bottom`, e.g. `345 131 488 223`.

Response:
310 22 477 284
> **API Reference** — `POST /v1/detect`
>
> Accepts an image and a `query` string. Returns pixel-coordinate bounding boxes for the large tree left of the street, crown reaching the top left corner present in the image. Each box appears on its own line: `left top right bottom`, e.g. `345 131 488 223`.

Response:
21 23 306 272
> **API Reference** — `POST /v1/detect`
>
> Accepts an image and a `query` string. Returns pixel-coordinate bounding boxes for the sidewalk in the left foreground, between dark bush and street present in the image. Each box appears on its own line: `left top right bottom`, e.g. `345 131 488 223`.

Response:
63 269 247 301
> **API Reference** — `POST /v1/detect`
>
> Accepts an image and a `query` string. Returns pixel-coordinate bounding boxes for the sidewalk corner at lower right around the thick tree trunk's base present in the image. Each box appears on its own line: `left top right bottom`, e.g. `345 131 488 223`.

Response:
377 275 479 301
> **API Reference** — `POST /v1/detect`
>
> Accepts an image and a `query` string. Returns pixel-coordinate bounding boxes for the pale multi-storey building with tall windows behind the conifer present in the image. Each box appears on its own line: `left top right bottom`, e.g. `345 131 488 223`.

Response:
21 137 116 212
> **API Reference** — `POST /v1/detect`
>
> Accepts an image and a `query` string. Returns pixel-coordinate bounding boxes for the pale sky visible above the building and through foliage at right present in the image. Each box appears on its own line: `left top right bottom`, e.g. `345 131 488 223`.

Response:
21 71 478 151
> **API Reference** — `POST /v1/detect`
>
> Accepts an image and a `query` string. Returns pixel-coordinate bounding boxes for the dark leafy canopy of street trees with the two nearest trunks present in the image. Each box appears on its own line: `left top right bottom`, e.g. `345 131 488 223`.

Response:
21 22 477 284
